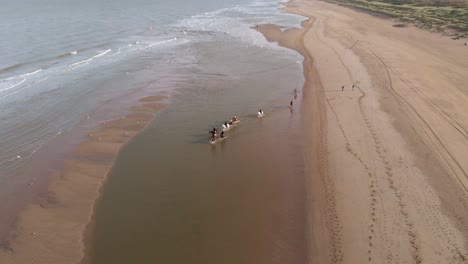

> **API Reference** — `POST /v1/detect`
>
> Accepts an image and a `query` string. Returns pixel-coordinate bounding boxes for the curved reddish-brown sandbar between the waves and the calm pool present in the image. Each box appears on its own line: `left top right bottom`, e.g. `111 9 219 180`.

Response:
0 96 167 264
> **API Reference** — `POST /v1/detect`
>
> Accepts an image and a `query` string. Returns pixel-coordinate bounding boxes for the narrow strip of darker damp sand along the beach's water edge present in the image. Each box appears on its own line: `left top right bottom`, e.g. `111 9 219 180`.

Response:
256 18 343 263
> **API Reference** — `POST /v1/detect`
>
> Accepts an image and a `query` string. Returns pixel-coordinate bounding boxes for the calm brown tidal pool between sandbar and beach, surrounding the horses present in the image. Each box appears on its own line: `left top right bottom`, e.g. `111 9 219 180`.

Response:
91 35 307 263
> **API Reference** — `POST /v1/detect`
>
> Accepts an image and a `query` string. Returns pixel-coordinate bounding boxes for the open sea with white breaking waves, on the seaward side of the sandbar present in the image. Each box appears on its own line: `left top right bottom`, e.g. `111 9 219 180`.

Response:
0 0 300 239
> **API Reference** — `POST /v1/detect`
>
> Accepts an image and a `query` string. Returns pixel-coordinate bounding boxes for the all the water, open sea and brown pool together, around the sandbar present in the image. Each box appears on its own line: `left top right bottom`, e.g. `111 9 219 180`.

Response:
0 0 306 263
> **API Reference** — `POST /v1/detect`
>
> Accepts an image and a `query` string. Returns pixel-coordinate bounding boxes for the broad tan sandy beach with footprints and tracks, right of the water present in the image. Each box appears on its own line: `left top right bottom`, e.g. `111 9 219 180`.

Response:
257 0 468 263
